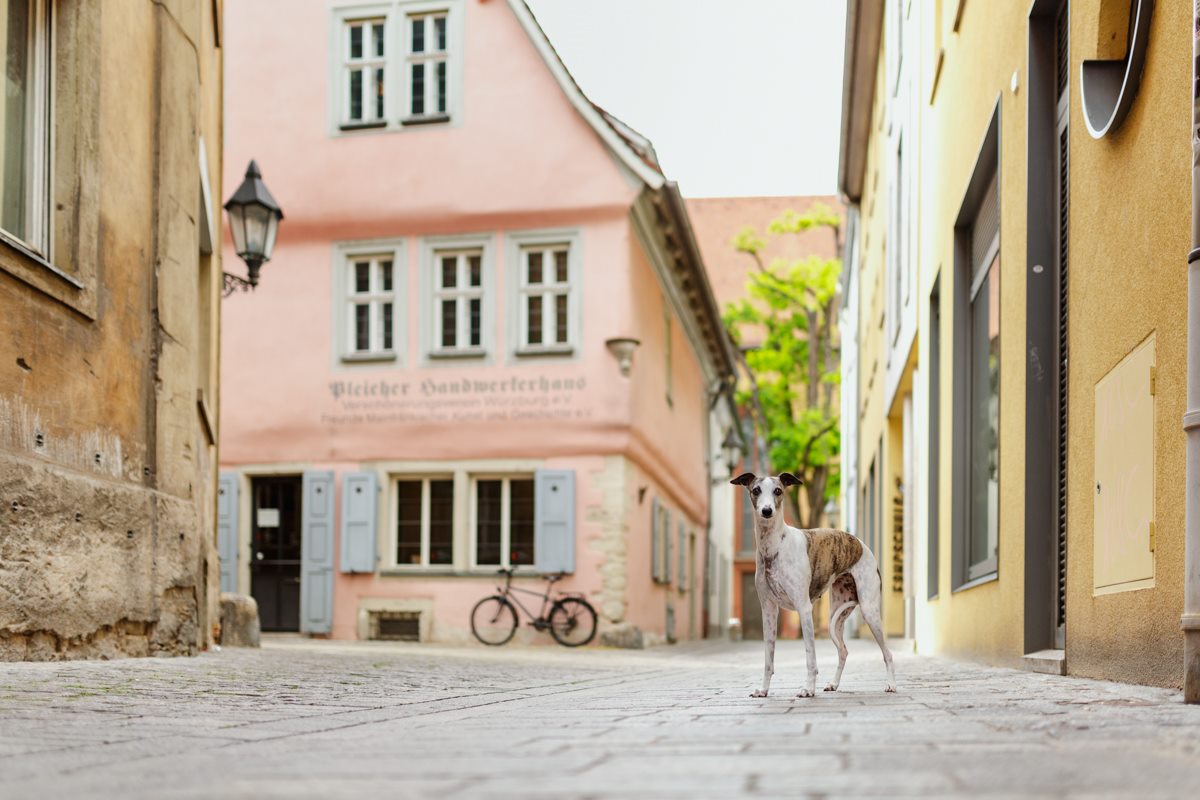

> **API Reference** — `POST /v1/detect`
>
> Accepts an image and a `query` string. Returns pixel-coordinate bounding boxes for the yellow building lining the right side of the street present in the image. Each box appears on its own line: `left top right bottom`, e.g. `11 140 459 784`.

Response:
840 0 1192 686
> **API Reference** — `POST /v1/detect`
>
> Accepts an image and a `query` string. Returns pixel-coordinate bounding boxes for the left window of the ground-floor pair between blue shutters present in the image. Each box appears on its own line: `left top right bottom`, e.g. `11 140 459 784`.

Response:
395 477 454 567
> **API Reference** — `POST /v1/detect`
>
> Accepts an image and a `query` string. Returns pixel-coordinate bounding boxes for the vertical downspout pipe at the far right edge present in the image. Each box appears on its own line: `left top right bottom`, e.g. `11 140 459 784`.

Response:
1180 0 1200 703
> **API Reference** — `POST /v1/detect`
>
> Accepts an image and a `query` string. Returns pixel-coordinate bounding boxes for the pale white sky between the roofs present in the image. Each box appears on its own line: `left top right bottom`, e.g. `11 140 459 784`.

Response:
527 0 846 197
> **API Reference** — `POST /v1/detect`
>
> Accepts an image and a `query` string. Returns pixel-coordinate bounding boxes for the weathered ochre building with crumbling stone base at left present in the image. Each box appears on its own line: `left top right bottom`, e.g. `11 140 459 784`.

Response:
0 0 222 660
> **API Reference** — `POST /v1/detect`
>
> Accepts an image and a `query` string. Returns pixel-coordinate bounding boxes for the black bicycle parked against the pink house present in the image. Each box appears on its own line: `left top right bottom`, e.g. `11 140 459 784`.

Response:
470 567 596 648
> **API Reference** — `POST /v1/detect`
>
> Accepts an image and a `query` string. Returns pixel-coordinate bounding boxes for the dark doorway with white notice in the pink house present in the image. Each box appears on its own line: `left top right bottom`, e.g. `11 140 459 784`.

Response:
250 475 302 631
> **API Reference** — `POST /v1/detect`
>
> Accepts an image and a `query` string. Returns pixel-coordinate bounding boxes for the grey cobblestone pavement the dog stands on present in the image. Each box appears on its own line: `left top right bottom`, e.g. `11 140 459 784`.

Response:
0 638 1200 800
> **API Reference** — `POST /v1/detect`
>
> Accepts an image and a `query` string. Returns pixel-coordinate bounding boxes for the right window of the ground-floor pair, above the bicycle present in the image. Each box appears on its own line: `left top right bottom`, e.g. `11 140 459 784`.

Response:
472 477 534 567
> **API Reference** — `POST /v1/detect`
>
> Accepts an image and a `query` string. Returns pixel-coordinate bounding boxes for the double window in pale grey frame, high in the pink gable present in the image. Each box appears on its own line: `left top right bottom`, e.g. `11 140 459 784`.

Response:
330 0 462 131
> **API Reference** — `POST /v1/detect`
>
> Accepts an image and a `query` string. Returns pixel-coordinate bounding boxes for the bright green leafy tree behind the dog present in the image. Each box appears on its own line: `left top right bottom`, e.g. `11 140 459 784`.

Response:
725 203 841 528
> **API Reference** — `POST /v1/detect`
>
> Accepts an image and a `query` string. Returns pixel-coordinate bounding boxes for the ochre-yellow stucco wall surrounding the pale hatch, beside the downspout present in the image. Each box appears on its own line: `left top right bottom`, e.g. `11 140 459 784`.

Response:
1067 0 1192 686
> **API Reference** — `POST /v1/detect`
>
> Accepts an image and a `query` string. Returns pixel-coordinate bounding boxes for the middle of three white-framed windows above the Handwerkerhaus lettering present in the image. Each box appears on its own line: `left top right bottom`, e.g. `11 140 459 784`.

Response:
433 248 484 355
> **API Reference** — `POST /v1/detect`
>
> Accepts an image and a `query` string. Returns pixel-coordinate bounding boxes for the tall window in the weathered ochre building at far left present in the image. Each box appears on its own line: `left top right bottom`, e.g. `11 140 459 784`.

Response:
0 0 50 257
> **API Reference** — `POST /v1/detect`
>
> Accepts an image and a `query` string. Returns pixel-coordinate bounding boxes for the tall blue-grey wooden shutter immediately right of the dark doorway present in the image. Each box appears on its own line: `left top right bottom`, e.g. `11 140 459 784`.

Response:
300 471 334 633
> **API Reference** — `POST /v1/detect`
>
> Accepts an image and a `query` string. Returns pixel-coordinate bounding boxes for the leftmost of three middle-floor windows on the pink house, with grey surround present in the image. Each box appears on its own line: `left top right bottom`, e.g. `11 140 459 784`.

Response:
335 241 403 361
